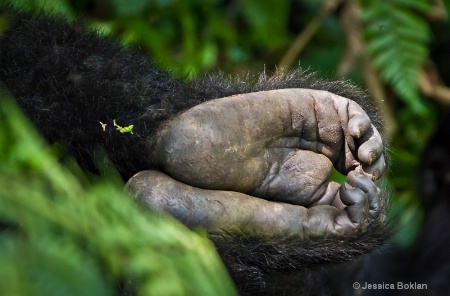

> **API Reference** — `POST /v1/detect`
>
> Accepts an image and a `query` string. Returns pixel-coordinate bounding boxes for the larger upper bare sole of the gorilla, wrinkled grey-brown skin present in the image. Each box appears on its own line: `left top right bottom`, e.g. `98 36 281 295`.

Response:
152 89 385 206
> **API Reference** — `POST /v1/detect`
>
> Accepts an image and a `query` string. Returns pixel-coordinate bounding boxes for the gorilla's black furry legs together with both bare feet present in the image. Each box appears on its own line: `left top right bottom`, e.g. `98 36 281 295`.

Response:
0 8 390 294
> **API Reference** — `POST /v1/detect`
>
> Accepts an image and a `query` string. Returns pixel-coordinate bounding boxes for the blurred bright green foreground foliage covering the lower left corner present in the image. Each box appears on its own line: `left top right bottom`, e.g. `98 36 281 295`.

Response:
0 92 236 296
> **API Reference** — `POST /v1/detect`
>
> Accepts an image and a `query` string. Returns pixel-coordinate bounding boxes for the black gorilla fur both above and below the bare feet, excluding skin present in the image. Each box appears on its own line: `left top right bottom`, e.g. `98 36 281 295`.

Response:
0 8 391 295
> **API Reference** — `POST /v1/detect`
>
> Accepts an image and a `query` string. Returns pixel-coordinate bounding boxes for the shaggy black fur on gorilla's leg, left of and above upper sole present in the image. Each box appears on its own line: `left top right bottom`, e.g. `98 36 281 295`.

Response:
0 9 381 179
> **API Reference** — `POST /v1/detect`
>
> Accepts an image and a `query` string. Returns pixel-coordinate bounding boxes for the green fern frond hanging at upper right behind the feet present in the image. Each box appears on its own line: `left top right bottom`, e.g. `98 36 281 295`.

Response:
361 0 431 112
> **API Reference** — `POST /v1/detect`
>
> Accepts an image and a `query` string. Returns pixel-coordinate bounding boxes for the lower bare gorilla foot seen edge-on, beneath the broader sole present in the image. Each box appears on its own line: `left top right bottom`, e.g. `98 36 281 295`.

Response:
126 171 380 240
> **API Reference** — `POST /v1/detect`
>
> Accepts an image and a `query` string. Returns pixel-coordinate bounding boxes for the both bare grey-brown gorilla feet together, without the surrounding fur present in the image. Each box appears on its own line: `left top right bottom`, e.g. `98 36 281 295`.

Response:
127 89 385 239
